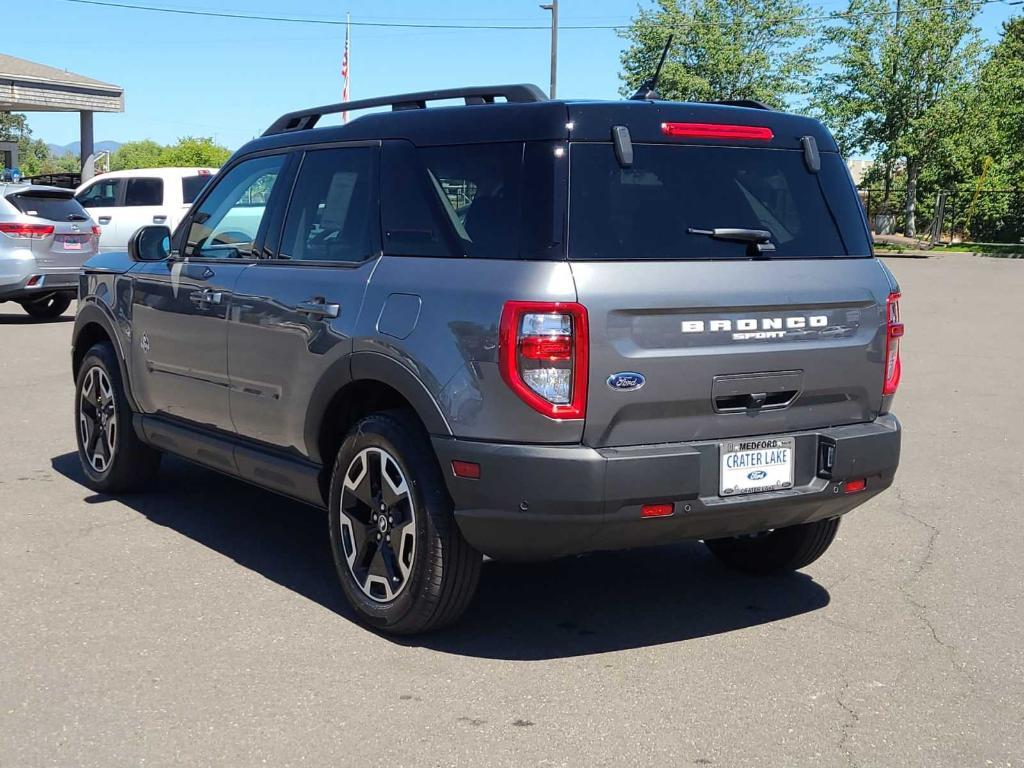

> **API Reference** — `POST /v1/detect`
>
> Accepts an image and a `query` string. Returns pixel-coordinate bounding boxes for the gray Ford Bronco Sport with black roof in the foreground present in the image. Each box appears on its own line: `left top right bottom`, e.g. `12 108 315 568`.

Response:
73 85 903 634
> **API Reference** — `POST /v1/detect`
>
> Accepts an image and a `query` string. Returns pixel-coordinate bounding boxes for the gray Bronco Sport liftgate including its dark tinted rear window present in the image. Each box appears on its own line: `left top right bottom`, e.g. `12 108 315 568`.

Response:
568 110 890 446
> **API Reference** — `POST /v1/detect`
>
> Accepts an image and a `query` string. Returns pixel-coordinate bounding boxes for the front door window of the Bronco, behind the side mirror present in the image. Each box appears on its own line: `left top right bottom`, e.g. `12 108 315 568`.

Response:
183 155 285 259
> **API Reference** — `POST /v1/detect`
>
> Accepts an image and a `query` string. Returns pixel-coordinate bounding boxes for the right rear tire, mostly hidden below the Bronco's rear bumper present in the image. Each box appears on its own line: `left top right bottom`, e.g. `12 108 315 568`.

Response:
705 517 839 574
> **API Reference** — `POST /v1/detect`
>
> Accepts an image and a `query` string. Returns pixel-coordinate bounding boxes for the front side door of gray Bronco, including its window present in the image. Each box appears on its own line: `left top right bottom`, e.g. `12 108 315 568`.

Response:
131 155 287 432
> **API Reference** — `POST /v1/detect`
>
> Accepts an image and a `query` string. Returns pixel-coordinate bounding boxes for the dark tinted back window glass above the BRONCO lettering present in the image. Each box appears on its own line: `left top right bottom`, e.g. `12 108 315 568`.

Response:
568 143 870 261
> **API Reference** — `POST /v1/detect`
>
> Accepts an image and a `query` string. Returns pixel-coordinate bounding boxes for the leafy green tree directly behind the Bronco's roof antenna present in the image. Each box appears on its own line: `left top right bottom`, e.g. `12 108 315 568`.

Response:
621 0 819 106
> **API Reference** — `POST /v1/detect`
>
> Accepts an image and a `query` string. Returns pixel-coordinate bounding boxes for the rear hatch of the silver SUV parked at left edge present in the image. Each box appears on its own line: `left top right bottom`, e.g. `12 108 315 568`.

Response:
7 187 98 273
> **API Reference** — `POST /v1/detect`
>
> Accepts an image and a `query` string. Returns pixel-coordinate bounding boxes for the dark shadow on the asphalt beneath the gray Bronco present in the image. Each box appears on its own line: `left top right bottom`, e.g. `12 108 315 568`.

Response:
51 454 829 660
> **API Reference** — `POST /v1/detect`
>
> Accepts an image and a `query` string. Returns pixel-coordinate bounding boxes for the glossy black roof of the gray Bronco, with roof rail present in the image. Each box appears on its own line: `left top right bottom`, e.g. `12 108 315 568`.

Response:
238 86 838 155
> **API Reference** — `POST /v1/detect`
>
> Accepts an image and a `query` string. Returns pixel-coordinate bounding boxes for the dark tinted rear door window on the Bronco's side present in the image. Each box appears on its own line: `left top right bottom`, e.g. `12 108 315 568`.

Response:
279 146 380 262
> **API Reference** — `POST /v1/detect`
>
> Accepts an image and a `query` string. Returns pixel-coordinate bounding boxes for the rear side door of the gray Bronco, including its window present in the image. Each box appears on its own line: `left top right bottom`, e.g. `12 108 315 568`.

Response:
227 142 380 461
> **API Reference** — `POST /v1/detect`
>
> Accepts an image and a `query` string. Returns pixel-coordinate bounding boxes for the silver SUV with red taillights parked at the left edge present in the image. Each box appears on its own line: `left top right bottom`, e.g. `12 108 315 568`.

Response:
0 183 99 318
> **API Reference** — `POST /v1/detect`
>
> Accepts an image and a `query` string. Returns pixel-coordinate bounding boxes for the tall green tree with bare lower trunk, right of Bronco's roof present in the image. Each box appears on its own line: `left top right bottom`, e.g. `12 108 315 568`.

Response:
815 0 982 237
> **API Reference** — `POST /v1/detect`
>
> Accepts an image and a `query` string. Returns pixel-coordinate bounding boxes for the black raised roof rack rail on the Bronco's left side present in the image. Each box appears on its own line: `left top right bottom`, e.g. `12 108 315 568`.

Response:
263 83 548 136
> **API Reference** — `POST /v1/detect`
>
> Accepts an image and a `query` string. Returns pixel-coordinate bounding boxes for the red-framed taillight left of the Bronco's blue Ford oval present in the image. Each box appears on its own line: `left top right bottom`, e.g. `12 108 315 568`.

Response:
499 301 590 419
